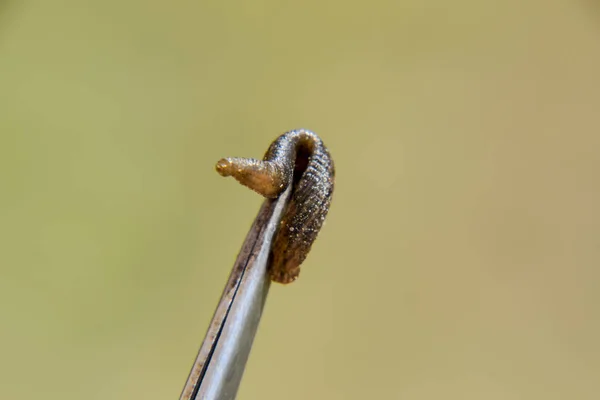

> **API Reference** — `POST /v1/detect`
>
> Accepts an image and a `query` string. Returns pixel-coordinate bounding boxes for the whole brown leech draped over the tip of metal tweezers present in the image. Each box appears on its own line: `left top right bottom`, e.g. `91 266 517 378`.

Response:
216 129 335 283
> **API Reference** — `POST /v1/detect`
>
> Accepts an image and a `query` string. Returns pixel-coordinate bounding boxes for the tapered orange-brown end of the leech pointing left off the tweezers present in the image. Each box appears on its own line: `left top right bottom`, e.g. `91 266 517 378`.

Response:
215 158 290 198
